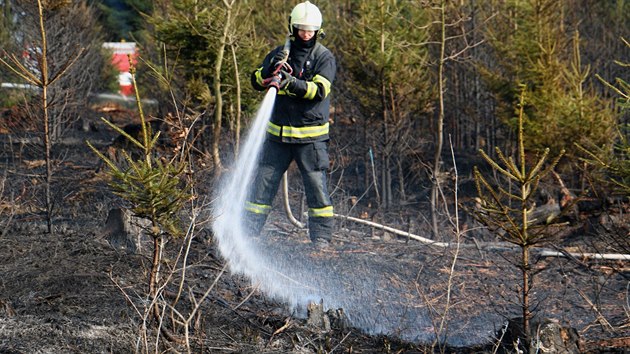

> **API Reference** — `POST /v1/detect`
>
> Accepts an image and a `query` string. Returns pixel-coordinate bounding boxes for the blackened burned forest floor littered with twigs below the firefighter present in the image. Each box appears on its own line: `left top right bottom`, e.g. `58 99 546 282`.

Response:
0 106 630 353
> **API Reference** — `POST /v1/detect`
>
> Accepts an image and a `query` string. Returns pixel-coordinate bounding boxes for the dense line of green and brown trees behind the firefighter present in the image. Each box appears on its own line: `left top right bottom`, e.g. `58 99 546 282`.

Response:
0 0 630 231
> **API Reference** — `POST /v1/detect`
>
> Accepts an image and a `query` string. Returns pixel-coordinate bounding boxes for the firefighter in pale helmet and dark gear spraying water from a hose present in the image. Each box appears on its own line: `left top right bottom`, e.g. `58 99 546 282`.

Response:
245 1 336 246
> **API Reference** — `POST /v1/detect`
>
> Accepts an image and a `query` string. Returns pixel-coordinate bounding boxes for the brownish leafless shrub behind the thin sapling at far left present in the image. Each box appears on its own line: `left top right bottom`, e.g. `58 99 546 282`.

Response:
9 0 105 140
